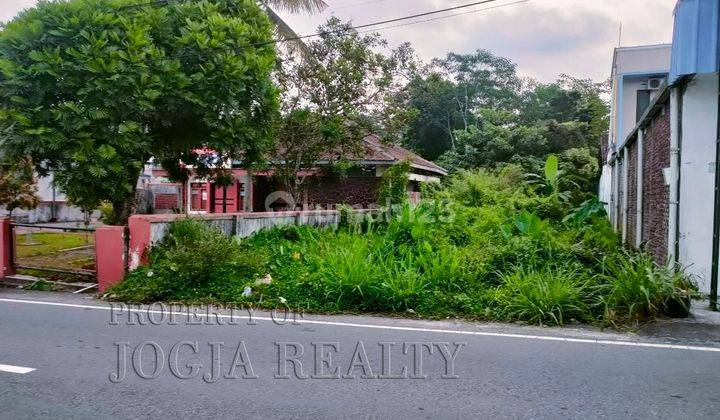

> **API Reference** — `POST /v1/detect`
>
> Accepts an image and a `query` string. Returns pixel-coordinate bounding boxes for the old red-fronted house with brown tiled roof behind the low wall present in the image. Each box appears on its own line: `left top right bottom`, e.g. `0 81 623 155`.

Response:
147 135 447 213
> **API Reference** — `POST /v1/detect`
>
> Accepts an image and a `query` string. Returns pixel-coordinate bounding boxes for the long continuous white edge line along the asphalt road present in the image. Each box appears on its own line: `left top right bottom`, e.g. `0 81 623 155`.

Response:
0 298 720 353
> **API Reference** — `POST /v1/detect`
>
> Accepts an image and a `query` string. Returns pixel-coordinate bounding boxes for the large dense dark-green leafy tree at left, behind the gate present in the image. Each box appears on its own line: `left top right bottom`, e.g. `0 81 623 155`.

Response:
0 0 278 224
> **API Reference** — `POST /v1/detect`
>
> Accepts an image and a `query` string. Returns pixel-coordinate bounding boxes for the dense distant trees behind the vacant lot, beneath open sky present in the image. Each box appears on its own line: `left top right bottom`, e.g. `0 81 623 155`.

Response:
404 50 609 192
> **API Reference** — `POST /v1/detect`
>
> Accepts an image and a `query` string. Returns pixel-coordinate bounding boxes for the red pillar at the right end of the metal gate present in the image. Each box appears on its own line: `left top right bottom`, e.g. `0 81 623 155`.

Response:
95 226 127 292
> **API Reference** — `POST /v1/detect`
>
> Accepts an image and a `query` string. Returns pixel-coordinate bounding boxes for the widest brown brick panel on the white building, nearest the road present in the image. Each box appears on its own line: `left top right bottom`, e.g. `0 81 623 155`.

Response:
643 110 670 264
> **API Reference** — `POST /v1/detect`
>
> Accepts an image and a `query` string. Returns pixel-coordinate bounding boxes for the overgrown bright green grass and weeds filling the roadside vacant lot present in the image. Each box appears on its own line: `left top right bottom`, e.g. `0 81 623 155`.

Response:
110 169 693 325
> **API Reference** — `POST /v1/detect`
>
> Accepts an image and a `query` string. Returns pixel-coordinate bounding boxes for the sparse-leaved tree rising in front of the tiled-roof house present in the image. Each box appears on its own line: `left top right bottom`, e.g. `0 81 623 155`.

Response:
272 18 413 200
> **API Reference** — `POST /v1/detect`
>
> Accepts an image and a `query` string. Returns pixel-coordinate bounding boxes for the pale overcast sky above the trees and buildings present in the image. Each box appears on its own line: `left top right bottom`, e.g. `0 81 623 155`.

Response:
0 0 676 81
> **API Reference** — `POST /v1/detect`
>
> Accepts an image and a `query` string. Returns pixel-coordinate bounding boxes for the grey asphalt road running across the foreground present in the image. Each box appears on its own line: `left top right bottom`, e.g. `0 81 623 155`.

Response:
0 289 720 419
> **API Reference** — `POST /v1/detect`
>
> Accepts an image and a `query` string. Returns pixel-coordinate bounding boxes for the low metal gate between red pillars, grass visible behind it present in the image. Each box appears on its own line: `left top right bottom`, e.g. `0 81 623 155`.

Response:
11 223 97 283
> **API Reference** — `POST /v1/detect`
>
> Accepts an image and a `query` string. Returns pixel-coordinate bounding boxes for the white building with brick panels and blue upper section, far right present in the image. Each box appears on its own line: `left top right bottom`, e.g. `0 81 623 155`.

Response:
601 0 720 306
